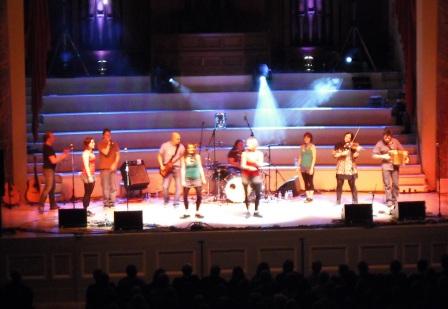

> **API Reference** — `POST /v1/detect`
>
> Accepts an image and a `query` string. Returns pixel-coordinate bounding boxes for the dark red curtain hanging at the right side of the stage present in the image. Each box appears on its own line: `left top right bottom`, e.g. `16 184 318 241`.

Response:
395 0 417 116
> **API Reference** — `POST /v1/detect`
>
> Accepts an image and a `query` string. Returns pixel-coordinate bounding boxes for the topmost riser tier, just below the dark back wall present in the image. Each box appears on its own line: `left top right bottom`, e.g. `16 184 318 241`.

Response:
46 72 401 94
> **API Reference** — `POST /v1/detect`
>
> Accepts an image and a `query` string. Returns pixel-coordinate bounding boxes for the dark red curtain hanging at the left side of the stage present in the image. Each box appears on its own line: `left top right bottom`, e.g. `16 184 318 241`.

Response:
27 0 50 142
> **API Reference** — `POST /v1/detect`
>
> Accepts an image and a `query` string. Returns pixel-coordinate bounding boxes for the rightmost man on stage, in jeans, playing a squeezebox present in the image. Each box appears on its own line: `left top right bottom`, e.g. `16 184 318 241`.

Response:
372 129 409 206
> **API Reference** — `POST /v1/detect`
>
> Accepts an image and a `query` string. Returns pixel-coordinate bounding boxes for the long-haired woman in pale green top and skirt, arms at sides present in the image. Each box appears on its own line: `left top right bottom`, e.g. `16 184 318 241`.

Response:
180 144 205 219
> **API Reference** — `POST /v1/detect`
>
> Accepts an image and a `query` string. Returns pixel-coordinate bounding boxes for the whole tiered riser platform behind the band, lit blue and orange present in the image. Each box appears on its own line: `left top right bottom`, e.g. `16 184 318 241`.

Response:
28 73 427 199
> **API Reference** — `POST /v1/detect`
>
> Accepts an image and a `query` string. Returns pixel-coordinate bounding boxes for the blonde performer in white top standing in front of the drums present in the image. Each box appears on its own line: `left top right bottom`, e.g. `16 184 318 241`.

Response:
241 137 264 218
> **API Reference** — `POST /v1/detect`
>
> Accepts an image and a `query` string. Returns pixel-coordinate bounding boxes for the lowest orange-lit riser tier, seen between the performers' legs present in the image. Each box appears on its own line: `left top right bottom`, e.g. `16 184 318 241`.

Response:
47 168 427 200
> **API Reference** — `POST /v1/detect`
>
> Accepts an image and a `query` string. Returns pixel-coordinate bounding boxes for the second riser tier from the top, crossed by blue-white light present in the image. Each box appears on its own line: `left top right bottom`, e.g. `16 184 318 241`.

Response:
42 90 387 113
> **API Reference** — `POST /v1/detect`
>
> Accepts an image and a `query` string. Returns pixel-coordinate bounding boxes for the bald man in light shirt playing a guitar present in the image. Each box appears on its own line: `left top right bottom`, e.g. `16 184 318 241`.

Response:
157 132 185 206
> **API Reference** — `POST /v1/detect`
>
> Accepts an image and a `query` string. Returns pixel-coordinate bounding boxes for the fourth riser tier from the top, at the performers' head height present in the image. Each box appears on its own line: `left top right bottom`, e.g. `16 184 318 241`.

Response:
28 126 415 150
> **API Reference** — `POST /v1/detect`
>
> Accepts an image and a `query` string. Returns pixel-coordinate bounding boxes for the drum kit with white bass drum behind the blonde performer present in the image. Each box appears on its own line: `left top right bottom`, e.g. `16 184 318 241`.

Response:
207 162 269 203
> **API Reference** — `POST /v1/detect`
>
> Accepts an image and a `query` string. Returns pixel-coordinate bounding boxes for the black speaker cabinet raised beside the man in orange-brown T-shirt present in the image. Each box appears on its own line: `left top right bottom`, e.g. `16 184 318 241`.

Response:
120 160 149 190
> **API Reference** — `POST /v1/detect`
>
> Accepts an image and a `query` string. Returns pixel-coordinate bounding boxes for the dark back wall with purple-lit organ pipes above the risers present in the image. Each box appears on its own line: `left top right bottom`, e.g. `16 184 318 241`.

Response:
38 0 398 74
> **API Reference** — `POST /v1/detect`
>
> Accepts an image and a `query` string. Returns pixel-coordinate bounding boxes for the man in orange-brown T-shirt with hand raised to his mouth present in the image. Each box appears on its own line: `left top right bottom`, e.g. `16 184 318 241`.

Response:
98 128 120 207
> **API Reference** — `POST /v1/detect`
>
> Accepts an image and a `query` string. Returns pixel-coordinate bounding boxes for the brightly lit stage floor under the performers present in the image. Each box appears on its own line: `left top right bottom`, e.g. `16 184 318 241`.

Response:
2 192 448 235
